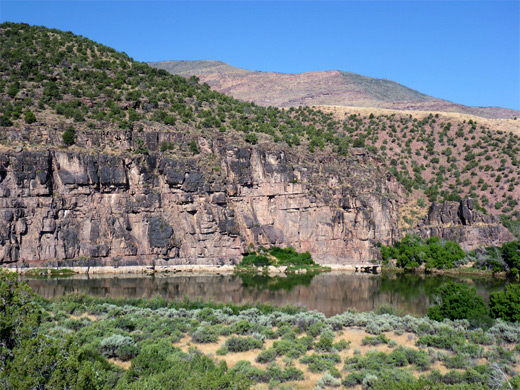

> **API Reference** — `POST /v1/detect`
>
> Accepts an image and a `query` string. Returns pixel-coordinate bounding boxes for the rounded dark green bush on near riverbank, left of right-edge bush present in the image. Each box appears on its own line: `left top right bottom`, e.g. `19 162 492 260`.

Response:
427 282 490 327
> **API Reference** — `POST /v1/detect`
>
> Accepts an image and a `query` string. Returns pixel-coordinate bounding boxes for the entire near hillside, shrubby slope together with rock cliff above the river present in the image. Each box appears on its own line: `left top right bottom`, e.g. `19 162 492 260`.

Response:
0 23 519 267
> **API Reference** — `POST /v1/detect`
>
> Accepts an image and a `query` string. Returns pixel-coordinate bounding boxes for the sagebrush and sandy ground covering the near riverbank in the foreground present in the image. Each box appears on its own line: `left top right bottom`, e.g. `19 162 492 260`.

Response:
0 270 520 389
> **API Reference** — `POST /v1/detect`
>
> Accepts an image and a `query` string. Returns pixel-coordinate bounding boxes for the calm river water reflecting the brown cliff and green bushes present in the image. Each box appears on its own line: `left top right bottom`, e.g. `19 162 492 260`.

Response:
27 272 503 316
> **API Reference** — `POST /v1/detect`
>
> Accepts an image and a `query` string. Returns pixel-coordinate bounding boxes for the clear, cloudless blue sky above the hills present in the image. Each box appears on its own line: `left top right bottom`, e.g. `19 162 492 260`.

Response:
0 0 520 109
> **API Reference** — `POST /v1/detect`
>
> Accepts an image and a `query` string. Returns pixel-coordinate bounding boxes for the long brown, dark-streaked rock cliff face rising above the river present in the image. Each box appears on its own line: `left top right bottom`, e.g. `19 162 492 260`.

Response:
0 139 402 266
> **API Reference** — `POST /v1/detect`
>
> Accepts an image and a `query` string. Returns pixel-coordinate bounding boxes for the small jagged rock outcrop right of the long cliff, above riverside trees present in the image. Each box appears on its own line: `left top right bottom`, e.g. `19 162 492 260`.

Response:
417 199 515 250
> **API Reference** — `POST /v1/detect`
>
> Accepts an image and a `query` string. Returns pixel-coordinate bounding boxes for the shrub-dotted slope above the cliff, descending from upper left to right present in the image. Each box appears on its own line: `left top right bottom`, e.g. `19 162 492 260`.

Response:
0 23 520 217
